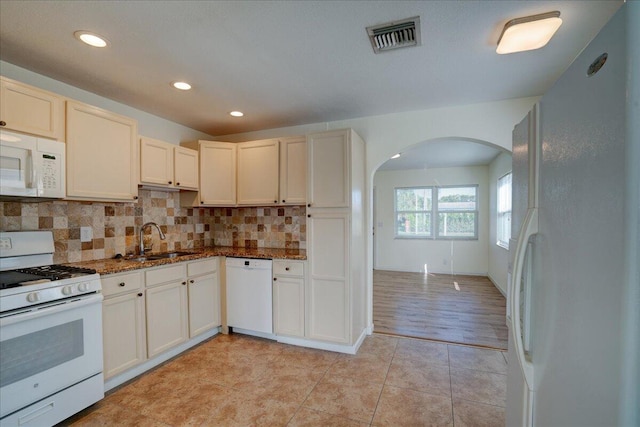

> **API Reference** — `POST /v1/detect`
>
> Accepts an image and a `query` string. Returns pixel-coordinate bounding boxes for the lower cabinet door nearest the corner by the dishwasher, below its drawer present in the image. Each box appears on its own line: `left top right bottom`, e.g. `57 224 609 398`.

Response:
189 271 221 338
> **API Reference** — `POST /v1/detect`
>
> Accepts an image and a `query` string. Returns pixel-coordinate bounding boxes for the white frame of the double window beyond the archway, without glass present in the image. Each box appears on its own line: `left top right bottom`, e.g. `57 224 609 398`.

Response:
393 184 480 240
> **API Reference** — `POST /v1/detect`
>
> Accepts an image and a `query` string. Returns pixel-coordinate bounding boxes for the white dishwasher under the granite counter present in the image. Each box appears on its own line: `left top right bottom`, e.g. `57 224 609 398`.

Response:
225 258 273 338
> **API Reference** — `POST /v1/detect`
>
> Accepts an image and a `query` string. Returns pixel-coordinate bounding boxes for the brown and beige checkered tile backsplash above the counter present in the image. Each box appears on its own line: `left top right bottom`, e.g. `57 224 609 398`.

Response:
0 189 306 263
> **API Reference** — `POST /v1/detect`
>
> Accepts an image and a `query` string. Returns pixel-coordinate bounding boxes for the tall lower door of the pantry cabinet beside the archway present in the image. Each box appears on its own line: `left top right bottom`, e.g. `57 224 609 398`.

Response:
307 212 350 343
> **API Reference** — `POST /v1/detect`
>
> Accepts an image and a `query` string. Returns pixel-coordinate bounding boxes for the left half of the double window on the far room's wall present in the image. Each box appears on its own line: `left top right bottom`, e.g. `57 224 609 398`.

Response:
396 187 433 237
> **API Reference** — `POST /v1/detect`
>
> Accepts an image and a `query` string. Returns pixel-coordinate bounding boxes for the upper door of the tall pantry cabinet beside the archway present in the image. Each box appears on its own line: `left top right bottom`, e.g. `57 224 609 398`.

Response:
307 130 351 208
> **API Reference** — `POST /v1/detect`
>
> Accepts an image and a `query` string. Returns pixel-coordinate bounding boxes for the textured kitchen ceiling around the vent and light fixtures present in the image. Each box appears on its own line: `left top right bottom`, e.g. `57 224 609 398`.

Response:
0 0 622 135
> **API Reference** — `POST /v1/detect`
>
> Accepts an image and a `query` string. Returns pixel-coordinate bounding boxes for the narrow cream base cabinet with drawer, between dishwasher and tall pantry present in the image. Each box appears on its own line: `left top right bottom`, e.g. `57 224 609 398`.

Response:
273 260 305 338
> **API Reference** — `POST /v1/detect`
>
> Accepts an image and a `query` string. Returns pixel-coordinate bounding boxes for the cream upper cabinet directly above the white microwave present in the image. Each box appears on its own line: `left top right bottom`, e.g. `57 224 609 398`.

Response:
0 77 64 141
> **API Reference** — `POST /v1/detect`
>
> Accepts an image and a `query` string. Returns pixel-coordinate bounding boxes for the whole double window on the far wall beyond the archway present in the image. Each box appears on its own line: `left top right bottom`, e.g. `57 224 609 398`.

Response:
395 185 478 240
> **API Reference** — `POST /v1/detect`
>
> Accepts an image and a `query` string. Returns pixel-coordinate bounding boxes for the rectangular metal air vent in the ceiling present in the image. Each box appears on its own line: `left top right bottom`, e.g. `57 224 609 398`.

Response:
367 16 420 53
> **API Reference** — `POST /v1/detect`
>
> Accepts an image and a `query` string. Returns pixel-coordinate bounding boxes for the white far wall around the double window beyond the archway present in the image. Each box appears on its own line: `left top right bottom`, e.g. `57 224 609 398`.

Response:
374 166 489 275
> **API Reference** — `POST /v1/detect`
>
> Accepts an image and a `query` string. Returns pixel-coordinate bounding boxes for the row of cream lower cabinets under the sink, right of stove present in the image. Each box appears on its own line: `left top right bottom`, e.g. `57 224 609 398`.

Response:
102 258 221 379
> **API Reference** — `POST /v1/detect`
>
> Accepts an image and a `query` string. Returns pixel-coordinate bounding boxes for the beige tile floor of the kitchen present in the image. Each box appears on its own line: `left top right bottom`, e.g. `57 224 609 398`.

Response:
61 334 507 427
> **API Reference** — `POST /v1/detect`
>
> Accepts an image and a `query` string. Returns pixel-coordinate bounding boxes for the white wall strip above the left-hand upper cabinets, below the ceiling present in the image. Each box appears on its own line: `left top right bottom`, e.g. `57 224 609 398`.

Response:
0 61 212 144
